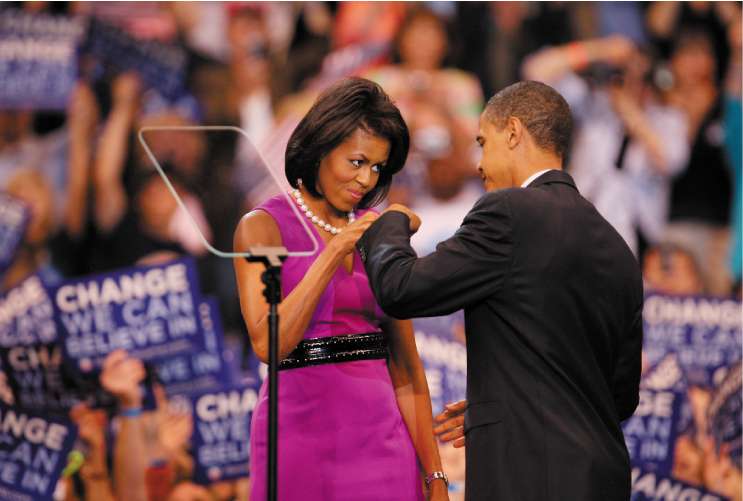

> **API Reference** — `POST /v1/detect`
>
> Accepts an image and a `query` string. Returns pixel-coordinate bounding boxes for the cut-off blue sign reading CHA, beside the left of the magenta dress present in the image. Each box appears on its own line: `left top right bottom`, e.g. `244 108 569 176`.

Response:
191 384 258 484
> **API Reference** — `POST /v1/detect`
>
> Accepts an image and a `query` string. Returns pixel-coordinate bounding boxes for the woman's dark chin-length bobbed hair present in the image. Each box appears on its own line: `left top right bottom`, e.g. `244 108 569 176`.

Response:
284 77 410 209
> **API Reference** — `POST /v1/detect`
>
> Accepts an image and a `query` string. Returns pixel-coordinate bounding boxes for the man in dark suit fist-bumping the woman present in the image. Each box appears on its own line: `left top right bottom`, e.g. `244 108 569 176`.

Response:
357 82 643 501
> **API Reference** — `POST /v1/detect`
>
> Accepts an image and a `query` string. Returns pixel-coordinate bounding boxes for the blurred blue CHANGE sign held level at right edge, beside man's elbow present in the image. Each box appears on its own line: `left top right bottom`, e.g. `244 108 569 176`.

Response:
643 294 743 387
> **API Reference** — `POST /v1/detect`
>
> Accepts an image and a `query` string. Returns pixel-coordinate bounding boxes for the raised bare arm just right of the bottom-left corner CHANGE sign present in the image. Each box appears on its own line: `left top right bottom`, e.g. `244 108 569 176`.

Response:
70 404 115 501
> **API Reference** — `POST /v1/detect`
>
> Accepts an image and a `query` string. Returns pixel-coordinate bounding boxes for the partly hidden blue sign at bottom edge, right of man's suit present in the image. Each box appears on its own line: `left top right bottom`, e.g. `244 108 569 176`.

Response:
630 467 728 501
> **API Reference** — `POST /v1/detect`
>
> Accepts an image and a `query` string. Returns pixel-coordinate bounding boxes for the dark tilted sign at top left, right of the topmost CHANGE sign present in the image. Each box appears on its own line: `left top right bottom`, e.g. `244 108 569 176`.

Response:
85 20 188 100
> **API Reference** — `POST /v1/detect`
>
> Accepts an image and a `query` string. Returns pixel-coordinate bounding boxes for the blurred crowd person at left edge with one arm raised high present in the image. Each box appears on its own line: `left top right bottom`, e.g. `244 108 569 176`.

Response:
0 83 98 291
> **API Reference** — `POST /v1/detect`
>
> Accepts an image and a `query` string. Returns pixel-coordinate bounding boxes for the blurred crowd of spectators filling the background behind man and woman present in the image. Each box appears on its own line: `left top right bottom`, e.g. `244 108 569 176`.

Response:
0 2 743 501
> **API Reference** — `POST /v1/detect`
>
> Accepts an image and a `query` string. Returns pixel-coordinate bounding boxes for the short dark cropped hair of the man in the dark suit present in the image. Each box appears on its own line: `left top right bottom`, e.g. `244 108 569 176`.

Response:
485 81 573 160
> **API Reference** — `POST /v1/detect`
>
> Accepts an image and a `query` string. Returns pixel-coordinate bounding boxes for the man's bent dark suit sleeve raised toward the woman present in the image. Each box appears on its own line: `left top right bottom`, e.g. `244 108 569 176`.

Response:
357 193 513 318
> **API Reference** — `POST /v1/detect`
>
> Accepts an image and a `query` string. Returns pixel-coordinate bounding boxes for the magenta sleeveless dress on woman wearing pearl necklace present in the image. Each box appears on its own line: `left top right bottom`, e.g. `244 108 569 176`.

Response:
250 196 423 501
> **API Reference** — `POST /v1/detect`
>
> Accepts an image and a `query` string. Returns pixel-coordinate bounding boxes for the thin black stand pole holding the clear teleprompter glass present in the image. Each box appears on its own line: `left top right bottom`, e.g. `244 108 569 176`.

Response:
245 246 288 501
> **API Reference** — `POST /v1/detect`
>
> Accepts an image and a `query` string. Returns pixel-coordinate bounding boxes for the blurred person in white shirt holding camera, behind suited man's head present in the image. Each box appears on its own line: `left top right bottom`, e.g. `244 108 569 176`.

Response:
523 36 688 255
